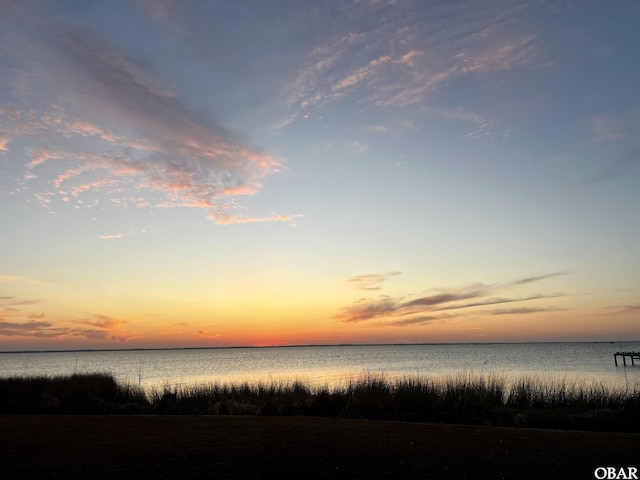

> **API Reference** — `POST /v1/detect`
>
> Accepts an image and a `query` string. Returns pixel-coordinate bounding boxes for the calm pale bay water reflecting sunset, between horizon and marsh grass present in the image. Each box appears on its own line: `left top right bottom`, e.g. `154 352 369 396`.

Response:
0 342 640 388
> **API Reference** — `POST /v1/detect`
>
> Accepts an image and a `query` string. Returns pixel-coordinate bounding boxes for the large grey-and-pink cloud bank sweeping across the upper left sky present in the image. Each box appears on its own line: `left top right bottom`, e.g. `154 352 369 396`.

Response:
0 6 296 223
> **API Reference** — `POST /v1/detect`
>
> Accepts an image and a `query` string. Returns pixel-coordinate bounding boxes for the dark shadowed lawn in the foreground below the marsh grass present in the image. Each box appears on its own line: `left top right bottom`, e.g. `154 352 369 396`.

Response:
0 415 640 480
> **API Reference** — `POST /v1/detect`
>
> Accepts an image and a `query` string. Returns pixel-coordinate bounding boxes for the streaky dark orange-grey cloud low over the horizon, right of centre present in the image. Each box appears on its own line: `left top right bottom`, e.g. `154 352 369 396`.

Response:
334 272 564 326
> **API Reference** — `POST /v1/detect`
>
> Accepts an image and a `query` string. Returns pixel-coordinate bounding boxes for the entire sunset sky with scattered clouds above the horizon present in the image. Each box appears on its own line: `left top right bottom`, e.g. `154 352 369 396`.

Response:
0 0 640 351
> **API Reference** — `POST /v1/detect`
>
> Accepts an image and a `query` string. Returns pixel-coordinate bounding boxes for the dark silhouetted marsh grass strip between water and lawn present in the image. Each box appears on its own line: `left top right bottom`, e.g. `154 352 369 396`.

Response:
0 372 640 432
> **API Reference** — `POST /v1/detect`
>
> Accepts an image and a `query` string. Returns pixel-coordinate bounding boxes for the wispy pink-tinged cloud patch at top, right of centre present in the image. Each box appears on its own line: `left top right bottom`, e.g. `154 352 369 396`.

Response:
286 1 544 114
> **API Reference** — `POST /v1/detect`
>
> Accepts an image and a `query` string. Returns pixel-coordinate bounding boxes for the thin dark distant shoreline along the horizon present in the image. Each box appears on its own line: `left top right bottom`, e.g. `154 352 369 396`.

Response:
0 339 640 354
